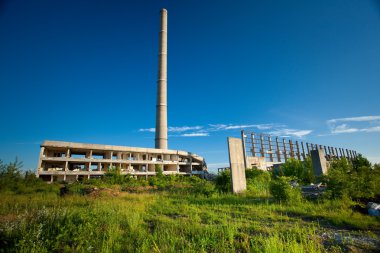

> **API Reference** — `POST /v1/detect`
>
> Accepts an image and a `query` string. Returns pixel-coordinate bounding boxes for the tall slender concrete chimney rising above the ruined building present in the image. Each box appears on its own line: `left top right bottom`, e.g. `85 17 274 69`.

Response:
155 9 168 149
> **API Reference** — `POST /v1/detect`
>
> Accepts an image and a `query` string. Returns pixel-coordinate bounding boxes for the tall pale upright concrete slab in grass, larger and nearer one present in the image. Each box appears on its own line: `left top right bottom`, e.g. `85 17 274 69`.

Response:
227 137 247 193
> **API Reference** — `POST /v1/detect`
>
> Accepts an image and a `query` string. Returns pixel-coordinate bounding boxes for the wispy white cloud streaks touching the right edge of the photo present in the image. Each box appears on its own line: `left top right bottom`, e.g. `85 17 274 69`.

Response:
327 116 380 134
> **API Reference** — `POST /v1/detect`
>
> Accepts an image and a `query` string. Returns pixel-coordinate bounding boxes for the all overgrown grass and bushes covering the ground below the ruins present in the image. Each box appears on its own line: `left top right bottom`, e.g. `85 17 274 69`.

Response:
0 157 380 252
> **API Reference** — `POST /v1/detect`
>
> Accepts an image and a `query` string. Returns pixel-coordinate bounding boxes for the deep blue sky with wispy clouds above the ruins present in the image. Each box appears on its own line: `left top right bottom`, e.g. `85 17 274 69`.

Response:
0 0 380 172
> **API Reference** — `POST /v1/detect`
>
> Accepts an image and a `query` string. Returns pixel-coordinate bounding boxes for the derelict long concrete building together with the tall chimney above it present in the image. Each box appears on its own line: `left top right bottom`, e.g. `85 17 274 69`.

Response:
37 9 207 182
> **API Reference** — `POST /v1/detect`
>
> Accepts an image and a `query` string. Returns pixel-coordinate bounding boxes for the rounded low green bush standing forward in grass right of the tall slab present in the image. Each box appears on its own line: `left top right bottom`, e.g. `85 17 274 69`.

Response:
269 177 302 203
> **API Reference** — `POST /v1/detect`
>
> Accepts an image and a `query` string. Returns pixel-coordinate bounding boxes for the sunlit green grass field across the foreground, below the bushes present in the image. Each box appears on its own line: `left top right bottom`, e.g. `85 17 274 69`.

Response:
0 191 380 252
